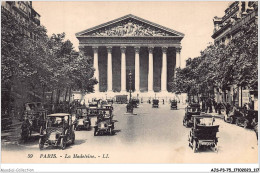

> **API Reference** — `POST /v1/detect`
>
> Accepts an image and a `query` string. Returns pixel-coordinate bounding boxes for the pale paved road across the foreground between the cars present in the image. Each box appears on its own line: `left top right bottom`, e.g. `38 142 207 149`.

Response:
2 104 258 163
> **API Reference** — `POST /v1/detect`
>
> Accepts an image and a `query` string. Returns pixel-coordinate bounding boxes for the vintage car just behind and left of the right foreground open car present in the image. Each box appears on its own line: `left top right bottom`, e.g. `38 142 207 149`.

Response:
182 103 201 127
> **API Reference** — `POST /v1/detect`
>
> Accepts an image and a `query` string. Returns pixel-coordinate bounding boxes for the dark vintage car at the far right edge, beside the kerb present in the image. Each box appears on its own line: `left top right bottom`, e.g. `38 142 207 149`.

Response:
236 110 258 128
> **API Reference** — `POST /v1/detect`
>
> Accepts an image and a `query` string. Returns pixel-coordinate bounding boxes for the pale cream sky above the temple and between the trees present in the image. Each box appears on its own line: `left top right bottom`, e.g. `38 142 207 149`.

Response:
33 1 229 67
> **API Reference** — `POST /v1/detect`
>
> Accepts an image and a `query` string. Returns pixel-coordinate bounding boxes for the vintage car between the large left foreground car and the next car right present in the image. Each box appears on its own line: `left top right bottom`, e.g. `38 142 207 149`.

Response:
75 106 91 131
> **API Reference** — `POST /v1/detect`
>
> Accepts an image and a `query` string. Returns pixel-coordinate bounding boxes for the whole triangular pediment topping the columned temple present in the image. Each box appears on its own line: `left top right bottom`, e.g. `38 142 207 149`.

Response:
76 14 184 37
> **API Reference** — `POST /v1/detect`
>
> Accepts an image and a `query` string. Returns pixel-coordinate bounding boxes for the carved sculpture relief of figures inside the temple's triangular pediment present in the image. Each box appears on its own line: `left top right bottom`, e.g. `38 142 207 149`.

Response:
91 21 170 36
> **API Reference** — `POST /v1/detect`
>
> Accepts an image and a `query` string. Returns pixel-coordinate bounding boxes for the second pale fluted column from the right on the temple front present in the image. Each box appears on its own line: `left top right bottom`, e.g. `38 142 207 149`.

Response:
161 47 167 92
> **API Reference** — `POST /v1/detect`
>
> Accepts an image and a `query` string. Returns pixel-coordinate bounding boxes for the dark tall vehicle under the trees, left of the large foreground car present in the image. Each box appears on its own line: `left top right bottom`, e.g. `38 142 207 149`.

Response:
21 102 47 140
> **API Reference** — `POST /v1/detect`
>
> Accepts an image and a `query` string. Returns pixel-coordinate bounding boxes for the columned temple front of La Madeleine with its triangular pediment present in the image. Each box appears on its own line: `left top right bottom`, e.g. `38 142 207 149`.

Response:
76 14 184 96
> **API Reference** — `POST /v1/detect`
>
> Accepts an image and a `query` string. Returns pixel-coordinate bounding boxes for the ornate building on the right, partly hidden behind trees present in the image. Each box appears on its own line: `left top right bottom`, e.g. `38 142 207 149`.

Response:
212 1 258 110
